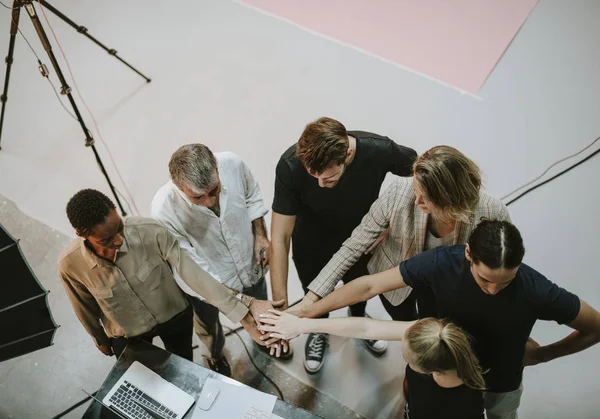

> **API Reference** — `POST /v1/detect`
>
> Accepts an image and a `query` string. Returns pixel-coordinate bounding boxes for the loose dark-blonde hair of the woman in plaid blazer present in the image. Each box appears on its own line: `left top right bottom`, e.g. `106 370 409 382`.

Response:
413 145 481 221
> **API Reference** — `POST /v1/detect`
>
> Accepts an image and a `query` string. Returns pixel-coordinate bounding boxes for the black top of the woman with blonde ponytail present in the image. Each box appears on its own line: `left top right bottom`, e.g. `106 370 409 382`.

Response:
404 365 484 419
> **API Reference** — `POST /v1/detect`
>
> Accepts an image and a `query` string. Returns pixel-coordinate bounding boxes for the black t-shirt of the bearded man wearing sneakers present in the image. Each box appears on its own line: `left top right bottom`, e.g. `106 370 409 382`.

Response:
273 131 417 264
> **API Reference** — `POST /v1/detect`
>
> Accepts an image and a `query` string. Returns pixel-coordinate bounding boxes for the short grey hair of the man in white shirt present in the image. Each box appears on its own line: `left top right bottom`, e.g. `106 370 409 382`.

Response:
169 144 218 193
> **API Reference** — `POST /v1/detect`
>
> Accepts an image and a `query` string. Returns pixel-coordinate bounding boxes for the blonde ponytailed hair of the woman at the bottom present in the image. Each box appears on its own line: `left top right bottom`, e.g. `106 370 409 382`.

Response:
405 317 485 390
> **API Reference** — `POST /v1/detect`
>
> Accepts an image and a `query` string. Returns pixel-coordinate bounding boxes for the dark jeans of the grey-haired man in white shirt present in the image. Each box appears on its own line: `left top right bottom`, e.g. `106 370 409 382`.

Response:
188 278 268 360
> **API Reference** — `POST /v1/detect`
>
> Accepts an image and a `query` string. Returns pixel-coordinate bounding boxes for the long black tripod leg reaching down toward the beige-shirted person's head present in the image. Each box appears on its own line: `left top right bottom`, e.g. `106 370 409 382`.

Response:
25 2 127 215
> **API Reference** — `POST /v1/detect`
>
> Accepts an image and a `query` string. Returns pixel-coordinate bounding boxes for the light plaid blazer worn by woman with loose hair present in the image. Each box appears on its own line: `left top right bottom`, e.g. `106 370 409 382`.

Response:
308 178 510 306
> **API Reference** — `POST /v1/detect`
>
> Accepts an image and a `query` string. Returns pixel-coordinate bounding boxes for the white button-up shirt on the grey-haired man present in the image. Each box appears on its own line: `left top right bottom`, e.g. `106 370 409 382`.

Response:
152 152 268 298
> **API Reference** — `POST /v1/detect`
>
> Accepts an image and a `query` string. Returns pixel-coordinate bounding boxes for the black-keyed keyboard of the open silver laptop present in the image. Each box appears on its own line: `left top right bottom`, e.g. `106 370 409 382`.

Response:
110 380 178 419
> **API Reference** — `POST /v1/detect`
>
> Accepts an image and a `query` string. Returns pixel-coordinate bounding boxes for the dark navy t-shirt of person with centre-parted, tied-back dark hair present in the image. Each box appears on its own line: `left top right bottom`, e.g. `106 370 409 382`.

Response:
400 245 580 393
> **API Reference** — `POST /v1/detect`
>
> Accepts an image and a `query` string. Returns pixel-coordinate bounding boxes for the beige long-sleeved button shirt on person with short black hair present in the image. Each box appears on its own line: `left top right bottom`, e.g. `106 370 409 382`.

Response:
58 217 248 345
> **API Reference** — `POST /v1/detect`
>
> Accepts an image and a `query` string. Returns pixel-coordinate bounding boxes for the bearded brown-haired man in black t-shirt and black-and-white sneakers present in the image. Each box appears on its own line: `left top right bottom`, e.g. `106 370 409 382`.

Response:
270 118 417 373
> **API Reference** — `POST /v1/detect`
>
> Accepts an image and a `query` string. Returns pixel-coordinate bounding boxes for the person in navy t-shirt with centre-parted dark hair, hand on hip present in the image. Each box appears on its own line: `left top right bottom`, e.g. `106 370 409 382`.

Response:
301 220 600 419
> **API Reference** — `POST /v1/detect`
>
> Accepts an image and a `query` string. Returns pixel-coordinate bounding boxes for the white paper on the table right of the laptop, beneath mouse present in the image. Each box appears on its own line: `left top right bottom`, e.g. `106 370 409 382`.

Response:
192 378 277 419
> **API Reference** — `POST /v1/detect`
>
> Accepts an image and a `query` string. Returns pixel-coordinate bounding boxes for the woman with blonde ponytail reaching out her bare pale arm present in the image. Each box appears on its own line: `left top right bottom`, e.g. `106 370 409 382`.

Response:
259 310 485 419
